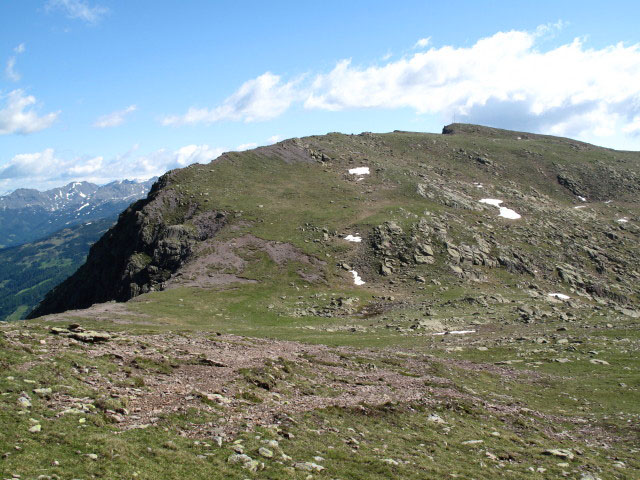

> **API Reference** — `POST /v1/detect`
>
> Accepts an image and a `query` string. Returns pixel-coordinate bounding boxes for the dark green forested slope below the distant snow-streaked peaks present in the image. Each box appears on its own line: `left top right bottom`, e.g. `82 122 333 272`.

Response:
0 218 115 321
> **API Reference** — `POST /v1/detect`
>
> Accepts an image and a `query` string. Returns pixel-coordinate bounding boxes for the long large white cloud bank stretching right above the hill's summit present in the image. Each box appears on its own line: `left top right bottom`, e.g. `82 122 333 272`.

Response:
163 22 640 146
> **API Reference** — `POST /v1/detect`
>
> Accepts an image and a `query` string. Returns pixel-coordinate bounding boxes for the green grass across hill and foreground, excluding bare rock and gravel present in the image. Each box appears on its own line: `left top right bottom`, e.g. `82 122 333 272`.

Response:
6 125 640 479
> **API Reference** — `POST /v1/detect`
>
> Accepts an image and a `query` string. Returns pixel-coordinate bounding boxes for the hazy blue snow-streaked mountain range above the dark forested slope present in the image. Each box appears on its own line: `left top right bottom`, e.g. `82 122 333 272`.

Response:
0 178 156 248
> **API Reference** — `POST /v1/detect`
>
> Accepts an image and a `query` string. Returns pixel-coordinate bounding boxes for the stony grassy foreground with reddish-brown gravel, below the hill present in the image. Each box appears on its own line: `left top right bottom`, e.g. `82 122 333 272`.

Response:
0 305 640 480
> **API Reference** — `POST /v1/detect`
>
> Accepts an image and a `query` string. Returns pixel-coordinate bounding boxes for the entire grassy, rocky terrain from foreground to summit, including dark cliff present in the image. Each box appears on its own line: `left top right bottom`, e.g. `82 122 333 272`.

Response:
10 125 640 480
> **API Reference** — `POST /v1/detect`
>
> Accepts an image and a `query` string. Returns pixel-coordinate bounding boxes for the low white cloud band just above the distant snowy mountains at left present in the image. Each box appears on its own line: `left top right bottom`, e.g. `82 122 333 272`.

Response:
0 145 224 191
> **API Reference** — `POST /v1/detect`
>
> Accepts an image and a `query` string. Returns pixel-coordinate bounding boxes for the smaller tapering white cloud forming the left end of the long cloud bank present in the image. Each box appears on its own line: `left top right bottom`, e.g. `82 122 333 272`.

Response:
162 72 300 125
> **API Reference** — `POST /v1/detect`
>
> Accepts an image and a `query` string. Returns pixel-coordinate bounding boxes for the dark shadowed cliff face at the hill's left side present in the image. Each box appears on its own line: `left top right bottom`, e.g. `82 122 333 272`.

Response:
29 174 226 318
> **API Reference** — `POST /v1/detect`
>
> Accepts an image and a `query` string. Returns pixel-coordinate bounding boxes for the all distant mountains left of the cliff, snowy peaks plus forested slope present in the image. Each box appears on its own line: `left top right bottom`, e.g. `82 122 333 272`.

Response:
0 178 156 321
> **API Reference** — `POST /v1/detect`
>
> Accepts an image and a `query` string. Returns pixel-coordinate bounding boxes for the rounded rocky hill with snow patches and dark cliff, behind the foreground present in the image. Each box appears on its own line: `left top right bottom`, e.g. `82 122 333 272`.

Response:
32 124 640 317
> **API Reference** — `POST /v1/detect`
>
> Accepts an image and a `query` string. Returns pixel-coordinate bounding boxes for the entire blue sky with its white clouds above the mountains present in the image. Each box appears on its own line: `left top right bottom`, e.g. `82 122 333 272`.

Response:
0 0 640 193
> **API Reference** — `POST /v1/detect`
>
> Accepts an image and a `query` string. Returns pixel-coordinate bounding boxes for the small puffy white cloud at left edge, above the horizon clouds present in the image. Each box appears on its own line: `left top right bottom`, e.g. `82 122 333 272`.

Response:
0 89 60 135
